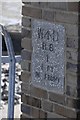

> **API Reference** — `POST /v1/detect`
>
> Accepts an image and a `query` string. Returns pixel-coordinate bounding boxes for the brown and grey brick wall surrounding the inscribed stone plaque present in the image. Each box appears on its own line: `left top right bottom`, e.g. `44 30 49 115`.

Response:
21 0 80 119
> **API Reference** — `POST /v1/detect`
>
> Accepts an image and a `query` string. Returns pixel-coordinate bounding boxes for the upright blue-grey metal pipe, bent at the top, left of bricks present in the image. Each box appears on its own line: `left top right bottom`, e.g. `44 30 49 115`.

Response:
2 26 16 119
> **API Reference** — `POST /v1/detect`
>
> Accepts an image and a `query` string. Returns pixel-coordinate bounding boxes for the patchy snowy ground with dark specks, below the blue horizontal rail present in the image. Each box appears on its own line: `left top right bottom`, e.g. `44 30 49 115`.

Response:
0 63 21 120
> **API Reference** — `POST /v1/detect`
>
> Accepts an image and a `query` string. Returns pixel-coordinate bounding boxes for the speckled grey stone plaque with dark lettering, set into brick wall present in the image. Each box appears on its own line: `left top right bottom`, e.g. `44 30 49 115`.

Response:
32 20 65 93
